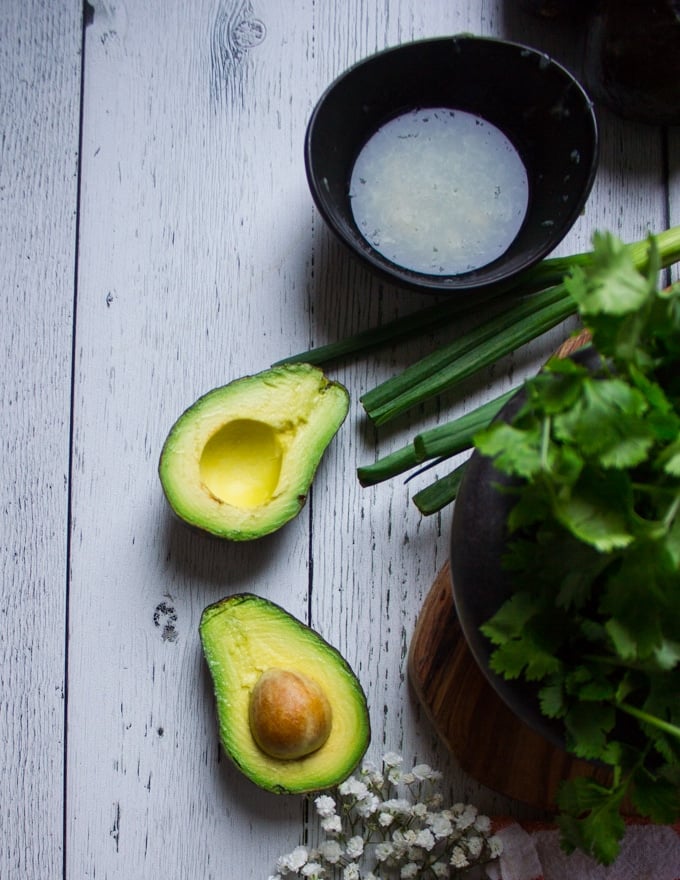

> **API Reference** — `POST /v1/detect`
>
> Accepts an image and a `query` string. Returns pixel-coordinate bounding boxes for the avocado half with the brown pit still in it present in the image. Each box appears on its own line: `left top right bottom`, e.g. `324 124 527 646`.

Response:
199 593 371 794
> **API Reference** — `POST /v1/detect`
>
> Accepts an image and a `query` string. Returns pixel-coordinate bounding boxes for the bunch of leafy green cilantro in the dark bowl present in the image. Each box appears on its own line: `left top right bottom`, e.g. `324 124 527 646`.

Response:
475 234 680 864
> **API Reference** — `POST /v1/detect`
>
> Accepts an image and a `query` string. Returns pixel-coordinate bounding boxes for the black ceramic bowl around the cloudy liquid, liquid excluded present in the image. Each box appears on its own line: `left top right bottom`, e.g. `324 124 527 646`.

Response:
305 35 598 293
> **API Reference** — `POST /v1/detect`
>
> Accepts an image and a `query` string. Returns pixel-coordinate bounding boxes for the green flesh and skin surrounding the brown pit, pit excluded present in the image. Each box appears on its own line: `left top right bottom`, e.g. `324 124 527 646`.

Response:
199 593 370 794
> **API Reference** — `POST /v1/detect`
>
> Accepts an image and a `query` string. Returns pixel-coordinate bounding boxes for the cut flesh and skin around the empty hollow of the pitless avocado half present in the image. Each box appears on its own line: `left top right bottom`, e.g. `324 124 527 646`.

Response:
158 364 349 541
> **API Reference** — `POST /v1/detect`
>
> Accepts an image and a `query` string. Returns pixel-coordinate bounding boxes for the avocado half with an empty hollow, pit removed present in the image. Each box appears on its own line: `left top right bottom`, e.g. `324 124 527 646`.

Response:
159 364 349 541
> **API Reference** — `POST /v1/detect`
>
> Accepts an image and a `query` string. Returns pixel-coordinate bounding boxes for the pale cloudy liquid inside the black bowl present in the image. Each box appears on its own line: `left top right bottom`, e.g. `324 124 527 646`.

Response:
350 107 529 275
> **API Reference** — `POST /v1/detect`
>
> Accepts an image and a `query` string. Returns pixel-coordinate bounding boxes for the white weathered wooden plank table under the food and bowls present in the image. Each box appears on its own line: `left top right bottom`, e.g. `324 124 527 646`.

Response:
0 0 680 880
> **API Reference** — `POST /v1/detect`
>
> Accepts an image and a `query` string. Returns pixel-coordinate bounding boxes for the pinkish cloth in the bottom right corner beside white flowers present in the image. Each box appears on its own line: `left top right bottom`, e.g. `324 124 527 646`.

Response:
488 820 680 880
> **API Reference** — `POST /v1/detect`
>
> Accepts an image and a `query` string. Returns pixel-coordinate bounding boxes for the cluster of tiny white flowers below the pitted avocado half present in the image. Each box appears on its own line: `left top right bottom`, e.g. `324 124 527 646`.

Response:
269 752 501 880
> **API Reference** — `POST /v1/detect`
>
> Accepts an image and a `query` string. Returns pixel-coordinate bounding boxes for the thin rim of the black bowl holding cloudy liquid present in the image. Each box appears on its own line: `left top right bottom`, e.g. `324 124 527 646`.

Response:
304 32 600 295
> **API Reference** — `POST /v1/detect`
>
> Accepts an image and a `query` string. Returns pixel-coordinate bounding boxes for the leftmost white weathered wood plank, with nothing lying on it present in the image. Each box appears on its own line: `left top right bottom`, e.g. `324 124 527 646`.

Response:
0 0 81 877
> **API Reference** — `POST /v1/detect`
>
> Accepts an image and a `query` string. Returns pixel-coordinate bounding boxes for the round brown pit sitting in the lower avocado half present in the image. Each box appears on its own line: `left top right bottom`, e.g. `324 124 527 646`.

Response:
248 669 333 760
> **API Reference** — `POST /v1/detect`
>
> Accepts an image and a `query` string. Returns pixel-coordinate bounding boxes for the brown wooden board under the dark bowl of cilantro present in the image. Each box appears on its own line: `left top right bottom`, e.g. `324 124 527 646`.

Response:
408 563 607 811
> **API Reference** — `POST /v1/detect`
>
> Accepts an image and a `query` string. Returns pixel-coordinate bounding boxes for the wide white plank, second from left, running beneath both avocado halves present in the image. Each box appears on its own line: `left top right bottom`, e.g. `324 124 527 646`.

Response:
67 2 311 880
